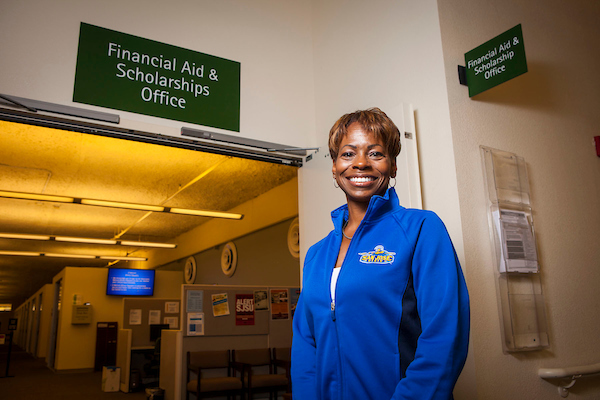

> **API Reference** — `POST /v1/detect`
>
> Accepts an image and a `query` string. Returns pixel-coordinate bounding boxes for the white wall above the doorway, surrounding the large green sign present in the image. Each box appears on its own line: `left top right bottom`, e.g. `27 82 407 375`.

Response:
0 0 314 147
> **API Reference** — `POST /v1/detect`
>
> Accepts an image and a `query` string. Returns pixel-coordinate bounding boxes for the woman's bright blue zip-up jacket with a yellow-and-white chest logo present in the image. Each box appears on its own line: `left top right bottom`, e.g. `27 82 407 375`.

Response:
292 188 469 400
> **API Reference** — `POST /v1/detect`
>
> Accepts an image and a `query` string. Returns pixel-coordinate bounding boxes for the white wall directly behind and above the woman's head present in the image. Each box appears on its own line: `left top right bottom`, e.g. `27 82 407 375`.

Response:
300 0 462 254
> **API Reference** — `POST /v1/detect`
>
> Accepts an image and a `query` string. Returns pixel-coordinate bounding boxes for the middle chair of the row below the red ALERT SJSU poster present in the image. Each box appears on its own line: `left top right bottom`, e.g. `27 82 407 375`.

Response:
233 348 289 400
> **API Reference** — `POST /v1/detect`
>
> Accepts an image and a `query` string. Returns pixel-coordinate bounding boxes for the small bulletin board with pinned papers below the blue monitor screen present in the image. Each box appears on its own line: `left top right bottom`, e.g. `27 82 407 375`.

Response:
123 298 181 347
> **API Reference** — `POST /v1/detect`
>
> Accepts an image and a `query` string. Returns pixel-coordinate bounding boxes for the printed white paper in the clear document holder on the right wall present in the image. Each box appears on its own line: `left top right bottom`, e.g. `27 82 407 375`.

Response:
492 209 539 273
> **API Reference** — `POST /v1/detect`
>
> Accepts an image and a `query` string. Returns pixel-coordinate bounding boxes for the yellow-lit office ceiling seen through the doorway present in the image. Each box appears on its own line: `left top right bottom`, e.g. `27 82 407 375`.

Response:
0 121 297 307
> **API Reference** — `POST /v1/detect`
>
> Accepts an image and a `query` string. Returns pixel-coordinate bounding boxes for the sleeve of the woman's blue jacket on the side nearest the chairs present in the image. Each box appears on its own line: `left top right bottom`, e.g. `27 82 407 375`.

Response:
292 248 319 400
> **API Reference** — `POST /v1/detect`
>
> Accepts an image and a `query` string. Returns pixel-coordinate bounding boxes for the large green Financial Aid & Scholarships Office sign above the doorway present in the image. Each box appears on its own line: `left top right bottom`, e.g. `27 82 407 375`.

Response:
73 23 240 132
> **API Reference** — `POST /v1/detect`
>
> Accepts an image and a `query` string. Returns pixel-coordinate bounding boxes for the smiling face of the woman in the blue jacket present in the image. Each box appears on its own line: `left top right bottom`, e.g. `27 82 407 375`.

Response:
332 122 396 203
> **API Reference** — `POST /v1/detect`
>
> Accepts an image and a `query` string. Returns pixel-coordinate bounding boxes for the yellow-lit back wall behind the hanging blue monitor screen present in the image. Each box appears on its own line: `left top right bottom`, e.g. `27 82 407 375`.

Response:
54 267 183 370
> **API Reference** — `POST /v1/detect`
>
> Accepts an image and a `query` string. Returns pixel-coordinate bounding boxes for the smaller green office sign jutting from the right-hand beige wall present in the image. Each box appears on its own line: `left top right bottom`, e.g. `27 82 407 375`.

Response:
465 24 527 97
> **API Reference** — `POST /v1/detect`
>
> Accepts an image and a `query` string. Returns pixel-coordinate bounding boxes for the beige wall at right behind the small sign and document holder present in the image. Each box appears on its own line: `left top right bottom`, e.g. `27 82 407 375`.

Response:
438 0 600 400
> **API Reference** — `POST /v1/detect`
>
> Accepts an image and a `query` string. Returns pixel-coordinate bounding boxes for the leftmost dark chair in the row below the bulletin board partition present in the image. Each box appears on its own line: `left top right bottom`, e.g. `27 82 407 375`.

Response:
185 350 245 400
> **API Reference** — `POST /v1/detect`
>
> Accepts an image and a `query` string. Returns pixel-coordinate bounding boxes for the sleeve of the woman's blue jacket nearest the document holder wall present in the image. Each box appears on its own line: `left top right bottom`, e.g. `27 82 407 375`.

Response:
392 213 469 400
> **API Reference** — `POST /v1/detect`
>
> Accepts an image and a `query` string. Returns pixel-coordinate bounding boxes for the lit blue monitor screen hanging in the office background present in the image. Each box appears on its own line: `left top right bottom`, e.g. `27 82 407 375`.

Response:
106 268 155 296
